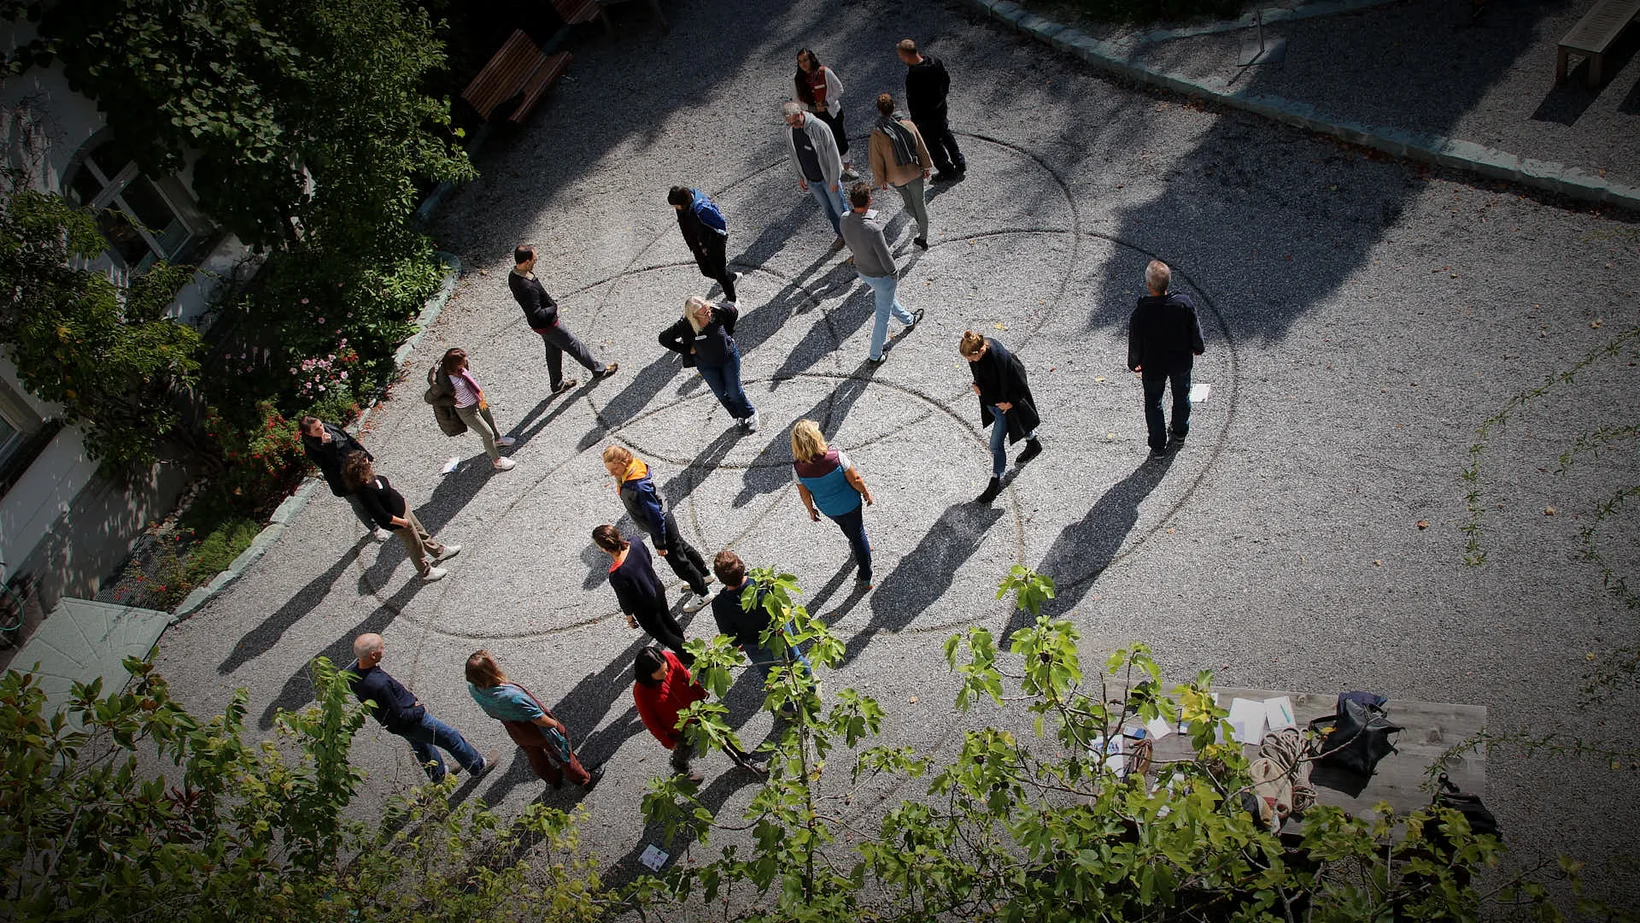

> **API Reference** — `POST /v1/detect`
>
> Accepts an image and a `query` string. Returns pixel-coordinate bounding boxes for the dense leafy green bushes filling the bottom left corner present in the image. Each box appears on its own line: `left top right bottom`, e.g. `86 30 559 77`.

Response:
0 657 605 923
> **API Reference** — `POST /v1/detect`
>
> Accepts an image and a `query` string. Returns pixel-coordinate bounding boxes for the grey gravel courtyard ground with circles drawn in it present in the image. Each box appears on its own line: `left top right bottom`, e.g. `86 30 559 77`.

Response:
150 0 1640 893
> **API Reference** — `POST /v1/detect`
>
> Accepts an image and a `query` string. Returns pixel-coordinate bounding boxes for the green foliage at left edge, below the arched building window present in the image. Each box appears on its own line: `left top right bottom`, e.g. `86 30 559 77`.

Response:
0 172 198 472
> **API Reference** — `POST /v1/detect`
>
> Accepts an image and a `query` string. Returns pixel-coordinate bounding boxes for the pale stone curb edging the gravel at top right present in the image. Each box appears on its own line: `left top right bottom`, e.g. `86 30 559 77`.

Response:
961 0 1640 211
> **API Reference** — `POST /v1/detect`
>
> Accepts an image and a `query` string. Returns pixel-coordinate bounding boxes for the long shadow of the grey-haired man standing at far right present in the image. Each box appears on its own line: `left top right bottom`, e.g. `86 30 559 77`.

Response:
999 452 1174 644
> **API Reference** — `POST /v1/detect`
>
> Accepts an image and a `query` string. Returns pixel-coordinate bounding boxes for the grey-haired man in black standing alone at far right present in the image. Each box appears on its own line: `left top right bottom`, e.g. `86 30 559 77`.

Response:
1128 259 1207 457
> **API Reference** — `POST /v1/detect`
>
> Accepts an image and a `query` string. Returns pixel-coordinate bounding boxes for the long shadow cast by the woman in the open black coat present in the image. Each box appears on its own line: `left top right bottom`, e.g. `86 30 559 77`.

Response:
843 500 1004 664
